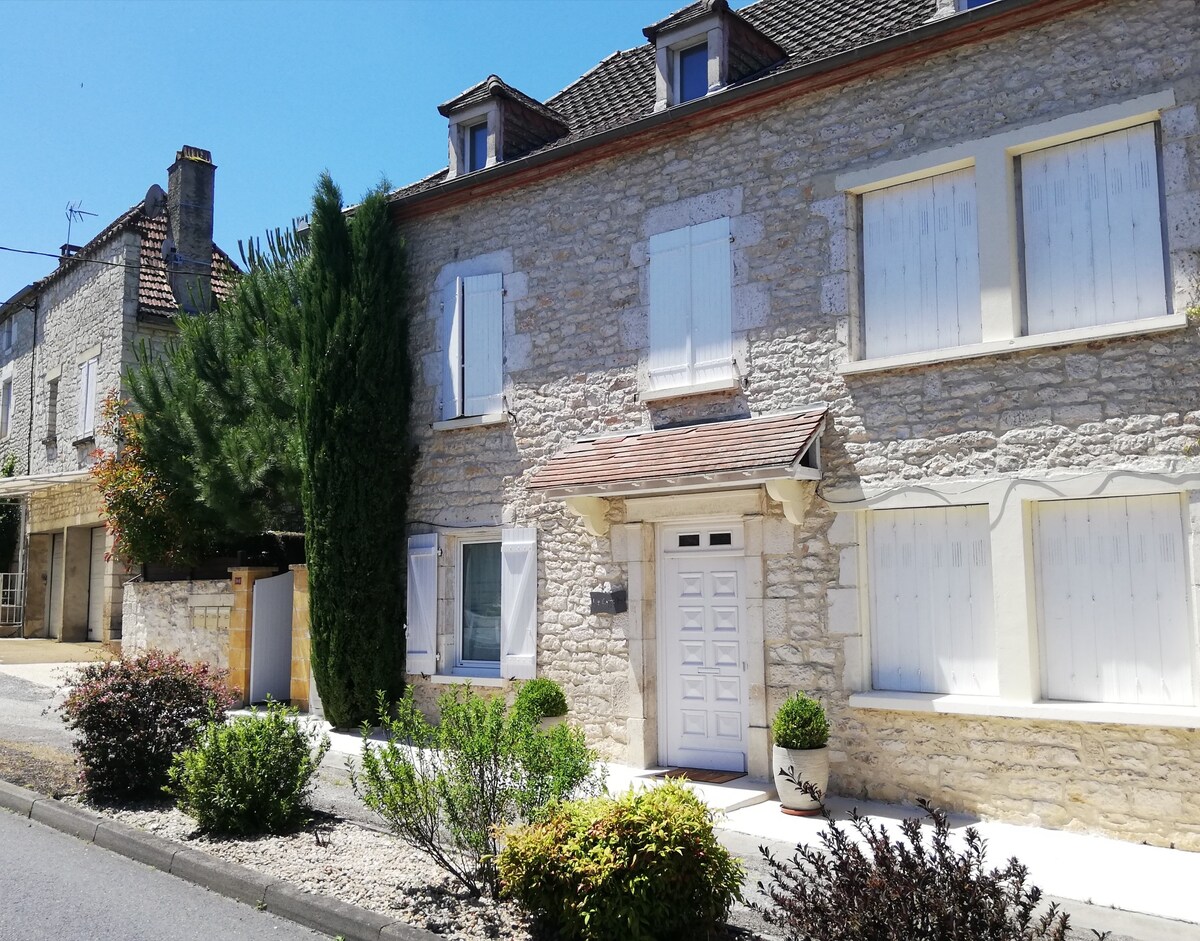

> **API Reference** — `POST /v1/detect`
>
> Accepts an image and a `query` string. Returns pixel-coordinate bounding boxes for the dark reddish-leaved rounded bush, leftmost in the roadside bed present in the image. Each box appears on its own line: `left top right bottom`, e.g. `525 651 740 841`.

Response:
59 651 236 798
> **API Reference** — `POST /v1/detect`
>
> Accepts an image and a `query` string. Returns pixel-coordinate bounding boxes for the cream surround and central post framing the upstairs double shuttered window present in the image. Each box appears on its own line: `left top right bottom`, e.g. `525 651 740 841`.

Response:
835 89 1187 374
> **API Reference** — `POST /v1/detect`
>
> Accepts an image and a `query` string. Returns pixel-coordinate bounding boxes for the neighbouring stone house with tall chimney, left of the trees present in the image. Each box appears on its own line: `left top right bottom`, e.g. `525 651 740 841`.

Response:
0 146 232 641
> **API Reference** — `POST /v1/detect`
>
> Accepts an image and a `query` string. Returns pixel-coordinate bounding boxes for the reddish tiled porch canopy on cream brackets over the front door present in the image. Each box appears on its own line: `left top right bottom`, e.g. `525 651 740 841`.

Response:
528 408 827 534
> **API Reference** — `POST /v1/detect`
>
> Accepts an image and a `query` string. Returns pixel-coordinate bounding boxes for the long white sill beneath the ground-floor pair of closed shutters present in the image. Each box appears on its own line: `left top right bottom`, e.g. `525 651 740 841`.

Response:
850 691 1200 729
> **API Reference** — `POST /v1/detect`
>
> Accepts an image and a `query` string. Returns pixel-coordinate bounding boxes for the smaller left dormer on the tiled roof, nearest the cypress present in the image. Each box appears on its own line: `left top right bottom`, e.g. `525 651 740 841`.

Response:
438 76 570 179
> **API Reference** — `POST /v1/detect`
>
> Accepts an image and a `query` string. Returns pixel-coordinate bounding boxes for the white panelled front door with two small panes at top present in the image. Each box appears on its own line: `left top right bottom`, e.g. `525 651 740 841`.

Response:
659 523 750 772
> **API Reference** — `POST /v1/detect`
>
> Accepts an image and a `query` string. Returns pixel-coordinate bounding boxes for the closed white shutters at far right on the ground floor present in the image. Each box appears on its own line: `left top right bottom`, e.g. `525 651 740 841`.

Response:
1034 495 1195 706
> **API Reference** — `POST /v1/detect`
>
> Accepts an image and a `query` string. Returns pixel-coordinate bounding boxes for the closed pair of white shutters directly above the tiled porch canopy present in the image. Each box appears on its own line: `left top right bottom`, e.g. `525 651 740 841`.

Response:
647 218 737 392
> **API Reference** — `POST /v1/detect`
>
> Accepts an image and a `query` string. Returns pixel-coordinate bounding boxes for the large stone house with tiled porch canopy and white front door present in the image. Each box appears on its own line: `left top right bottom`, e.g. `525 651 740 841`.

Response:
394 0 1200 850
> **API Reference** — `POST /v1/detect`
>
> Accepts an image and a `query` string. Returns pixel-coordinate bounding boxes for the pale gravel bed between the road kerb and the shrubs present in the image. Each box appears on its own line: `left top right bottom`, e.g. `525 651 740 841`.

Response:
82 803 532 941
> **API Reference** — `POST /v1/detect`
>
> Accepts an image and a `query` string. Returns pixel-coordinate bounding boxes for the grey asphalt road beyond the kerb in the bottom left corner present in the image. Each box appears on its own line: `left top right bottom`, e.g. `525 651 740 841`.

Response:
0 810 328 941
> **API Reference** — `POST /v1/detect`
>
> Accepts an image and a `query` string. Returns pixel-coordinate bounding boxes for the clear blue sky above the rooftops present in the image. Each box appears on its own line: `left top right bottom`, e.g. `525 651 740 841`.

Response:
0 0 676 294
